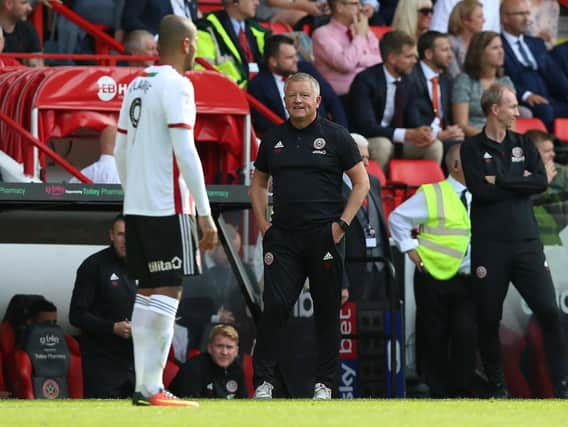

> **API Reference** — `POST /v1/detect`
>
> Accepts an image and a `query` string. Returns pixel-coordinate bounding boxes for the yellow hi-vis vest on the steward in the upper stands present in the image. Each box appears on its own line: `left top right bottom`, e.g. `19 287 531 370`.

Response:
196 13 267 87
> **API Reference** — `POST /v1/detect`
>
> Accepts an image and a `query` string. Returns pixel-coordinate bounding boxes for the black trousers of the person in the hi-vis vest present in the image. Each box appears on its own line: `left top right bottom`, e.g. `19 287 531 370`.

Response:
414 271 476 398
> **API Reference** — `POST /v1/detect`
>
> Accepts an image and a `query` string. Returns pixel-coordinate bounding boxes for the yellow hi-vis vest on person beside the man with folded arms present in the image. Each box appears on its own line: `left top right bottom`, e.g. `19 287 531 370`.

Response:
416 181 471 280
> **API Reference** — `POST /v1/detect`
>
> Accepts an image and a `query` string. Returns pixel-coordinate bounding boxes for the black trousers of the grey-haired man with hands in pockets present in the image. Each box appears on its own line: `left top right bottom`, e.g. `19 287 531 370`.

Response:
254 223 345 388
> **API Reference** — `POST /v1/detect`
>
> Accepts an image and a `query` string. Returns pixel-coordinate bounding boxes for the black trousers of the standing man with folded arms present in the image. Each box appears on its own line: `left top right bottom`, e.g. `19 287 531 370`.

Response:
471 239 567 385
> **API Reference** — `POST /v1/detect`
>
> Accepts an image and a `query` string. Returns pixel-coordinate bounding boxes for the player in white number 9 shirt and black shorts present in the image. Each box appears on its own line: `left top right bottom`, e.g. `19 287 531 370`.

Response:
114 15 217 407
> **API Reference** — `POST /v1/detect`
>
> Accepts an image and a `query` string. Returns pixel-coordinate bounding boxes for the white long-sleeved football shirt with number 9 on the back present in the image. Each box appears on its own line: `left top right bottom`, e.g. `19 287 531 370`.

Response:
114 65 211 216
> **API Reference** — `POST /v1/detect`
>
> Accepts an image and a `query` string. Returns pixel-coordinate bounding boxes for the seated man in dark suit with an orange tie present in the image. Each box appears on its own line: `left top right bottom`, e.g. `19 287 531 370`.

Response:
411 31 464 148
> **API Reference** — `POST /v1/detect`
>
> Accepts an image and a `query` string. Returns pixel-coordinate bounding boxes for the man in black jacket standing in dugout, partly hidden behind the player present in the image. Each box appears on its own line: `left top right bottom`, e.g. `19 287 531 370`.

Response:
69 215 136 398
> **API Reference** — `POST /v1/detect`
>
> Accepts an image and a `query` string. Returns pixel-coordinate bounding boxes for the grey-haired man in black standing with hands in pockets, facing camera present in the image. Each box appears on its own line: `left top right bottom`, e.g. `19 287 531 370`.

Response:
250 73 369 399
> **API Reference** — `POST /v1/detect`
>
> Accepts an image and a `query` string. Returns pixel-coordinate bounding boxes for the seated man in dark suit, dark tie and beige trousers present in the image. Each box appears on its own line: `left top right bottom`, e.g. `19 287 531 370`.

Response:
347 31 443 170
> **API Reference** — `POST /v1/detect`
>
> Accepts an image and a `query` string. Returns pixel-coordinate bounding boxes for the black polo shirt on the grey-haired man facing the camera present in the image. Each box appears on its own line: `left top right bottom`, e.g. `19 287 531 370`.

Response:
255 118 361 230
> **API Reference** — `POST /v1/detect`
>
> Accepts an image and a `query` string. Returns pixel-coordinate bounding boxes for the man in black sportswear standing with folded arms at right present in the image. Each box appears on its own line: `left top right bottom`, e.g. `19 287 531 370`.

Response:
461 84 568 398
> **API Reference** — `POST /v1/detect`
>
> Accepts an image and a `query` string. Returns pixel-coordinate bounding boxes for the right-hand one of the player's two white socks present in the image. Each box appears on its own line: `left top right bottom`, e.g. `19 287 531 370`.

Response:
142 295 178 396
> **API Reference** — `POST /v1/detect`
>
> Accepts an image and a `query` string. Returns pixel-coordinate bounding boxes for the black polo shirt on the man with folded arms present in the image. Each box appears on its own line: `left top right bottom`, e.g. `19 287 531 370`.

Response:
461 129 547 241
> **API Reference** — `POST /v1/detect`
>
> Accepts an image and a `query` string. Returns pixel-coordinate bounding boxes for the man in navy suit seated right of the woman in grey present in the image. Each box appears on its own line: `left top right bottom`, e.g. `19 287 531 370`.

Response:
501 0 568 131
